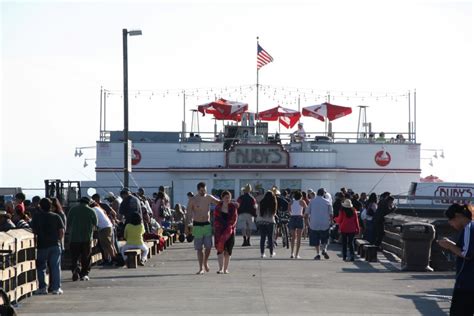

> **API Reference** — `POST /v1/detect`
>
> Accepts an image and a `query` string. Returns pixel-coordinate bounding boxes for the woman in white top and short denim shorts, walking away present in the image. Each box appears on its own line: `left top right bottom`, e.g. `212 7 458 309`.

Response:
288 191 308 259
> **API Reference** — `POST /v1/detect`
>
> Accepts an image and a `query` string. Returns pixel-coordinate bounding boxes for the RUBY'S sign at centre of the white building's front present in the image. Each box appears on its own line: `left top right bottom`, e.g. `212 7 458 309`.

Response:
227 144 290 169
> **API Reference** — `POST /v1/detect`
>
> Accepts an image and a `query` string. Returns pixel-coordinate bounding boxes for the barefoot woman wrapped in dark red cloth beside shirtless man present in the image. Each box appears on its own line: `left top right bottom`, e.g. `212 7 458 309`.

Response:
214 191 238 274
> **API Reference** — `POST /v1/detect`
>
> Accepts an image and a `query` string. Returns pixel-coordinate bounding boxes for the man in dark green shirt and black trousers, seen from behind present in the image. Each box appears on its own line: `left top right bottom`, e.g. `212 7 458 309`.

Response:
67 197 98 281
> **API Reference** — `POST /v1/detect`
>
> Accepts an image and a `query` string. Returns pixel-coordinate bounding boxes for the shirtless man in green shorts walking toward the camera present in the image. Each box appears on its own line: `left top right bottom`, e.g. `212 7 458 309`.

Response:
186 182 220 274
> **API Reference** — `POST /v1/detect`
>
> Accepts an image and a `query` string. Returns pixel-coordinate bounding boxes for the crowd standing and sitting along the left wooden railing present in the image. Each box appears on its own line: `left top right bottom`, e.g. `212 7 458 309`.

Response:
0 186 187 295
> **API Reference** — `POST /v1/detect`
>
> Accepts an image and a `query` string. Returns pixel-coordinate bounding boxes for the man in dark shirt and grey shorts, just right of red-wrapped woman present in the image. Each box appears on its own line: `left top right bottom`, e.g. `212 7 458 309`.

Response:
237 184 257 247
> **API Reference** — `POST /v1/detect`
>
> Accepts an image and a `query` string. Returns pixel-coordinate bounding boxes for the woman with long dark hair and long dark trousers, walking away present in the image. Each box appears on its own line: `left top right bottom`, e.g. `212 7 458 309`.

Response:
256 191 277 258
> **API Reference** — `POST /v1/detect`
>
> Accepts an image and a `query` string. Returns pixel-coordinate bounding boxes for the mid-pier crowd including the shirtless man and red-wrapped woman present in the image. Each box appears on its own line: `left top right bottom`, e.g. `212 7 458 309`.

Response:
181 182 395 274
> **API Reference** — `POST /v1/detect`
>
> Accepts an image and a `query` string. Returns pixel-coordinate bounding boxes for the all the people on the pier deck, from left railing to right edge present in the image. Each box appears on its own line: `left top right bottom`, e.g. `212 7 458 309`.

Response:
0 182 474 311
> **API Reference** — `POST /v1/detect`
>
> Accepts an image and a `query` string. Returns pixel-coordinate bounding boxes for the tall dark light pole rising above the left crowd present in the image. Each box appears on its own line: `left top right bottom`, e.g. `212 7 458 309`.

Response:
122 29 142 187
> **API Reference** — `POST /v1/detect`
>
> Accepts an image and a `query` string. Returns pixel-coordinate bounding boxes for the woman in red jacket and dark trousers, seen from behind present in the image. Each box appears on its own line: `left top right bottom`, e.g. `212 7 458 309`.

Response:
336 199 360 261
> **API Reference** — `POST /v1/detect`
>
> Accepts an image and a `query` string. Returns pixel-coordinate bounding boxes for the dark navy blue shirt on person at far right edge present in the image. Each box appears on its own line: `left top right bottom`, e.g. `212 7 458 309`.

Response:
454 222 474 290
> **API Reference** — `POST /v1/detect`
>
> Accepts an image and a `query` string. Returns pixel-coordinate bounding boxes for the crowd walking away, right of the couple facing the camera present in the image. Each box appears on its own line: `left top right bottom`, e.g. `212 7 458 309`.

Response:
231 184 395 261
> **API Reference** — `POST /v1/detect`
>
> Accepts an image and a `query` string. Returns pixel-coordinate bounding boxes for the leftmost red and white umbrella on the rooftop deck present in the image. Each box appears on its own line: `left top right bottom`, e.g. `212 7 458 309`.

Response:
198 99 248 121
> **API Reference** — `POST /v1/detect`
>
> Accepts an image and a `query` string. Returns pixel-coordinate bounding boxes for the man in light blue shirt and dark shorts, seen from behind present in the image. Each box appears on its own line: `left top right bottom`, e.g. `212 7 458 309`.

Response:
305 188 333 260
